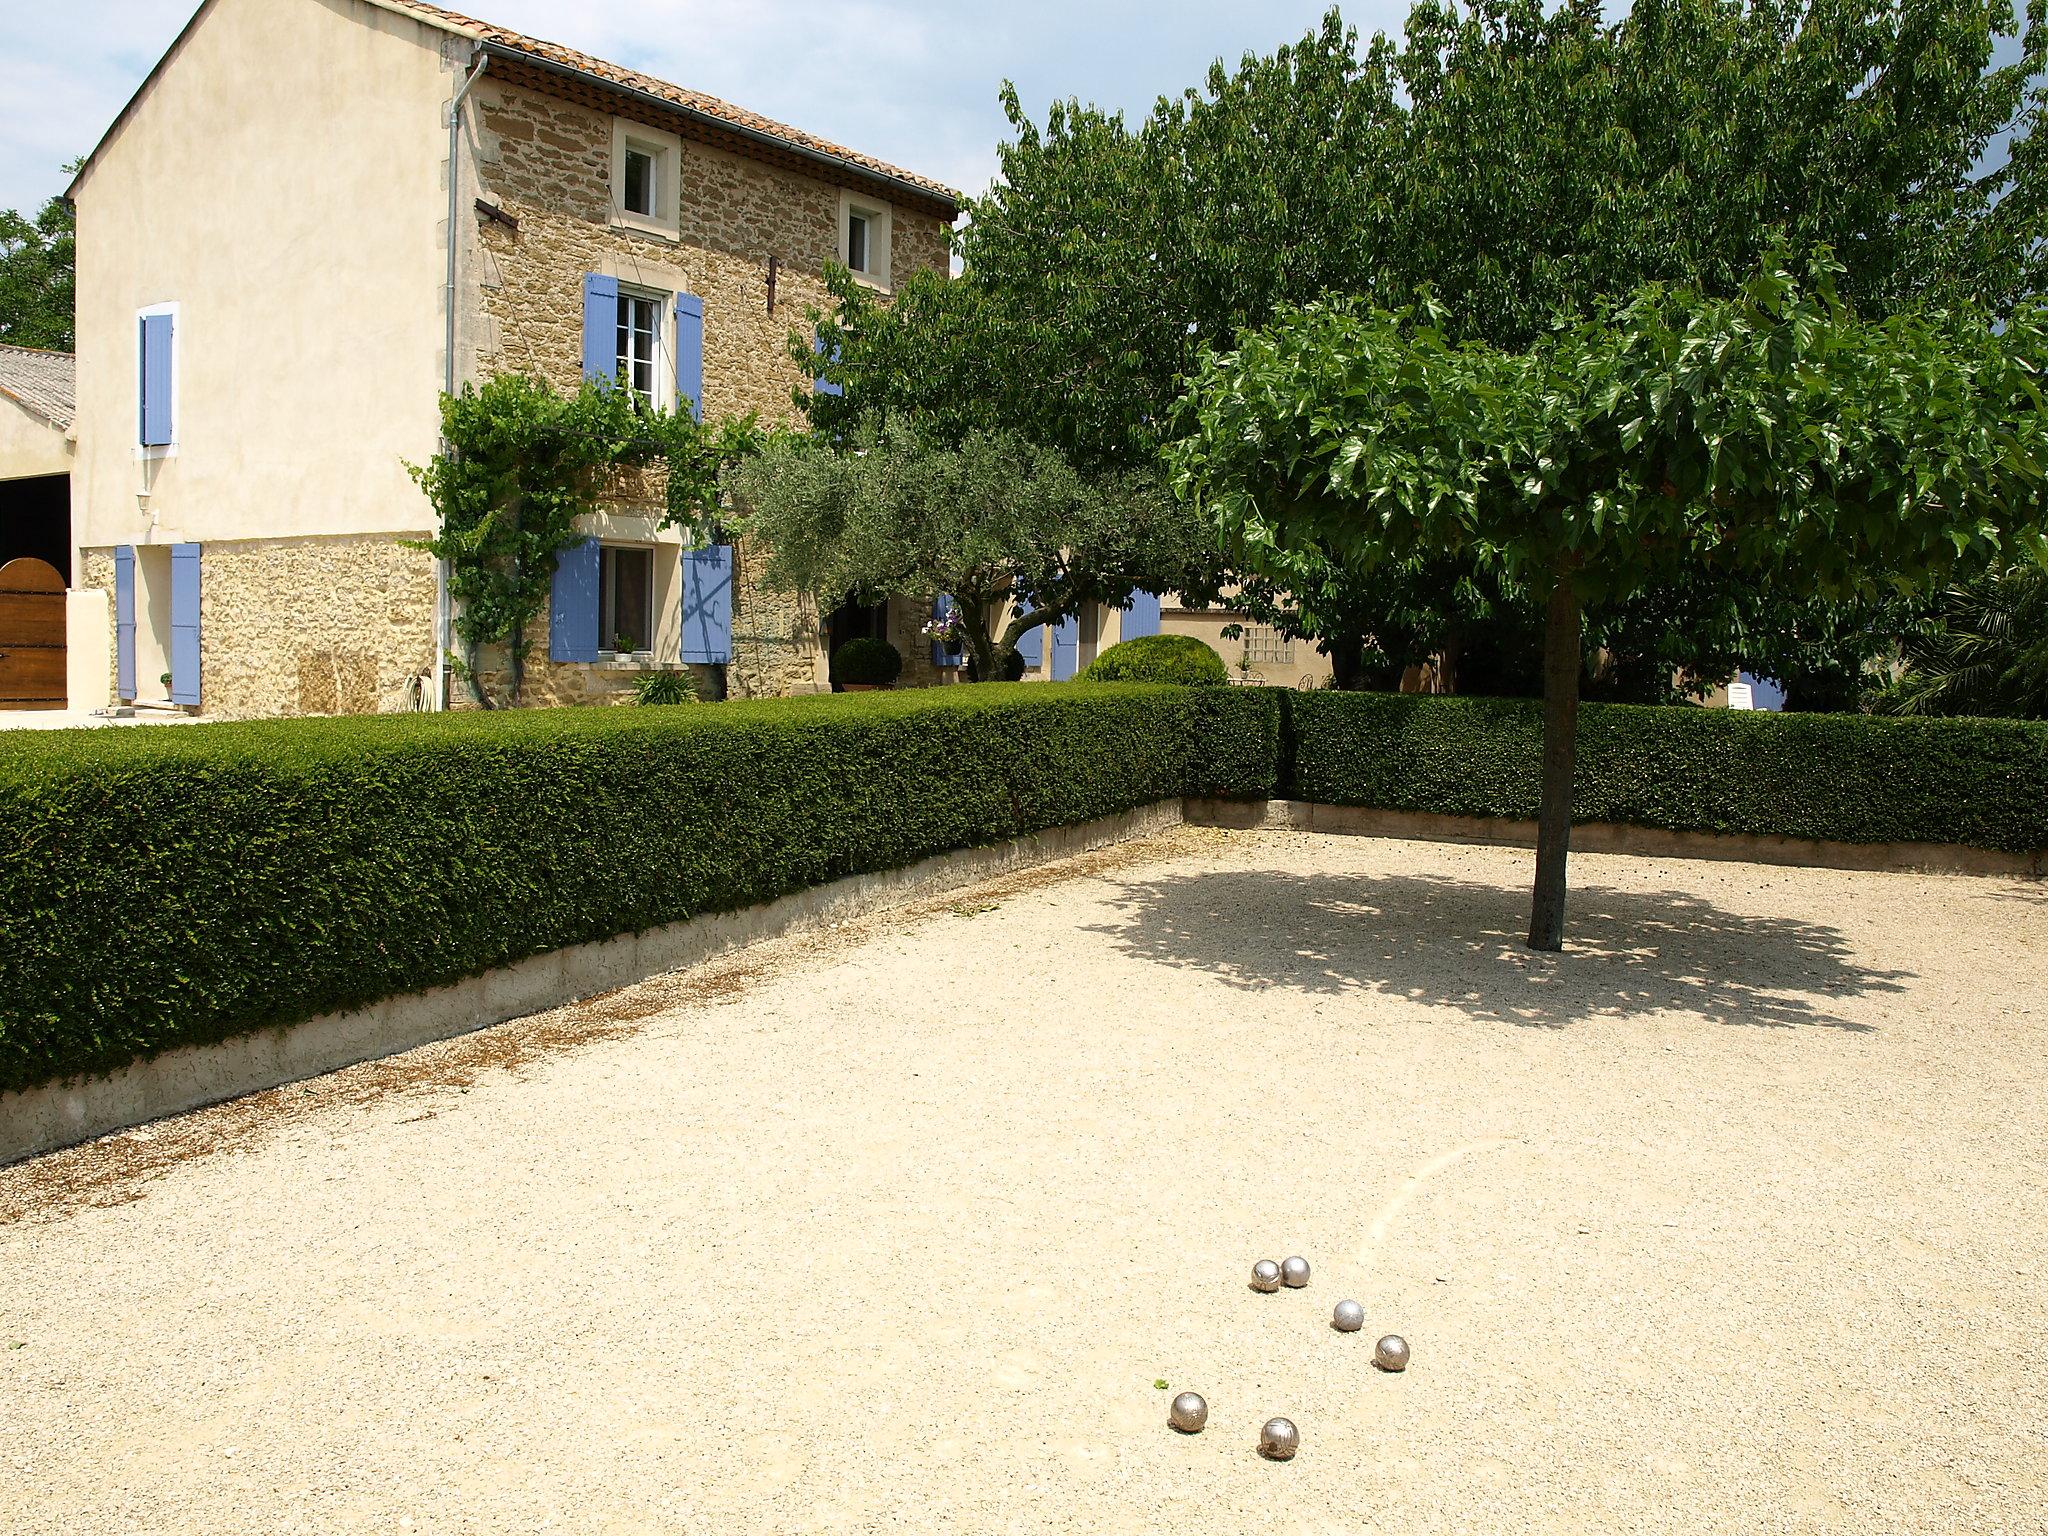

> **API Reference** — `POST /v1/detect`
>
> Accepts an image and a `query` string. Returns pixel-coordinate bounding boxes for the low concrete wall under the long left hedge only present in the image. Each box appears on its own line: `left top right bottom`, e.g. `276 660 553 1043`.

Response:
0 801 1182 1163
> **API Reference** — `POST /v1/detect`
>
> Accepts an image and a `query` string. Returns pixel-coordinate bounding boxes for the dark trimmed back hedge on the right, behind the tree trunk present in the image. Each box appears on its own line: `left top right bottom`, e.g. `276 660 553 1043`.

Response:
1286 692 2048 852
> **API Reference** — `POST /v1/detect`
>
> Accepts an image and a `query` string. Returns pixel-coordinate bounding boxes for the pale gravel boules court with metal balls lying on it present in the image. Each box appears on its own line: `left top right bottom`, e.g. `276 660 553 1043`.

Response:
0 831 2048 1536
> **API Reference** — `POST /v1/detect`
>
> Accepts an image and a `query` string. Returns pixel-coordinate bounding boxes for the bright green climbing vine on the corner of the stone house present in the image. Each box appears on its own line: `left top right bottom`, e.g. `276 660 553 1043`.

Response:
408 373 760 709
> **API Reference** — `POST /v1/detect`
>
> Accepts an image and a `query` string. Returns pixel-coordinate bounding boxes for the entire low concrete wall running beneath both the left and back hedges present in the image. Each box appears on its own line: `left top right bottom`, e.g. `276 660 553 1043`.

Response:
12 799 2042 1163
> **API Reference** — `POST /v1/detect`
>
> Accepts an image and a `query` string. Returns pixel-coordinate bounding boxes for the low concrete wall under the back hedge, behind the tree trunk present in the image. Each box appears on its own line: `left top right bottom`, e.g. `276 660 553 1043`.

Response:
1188 799 2044 879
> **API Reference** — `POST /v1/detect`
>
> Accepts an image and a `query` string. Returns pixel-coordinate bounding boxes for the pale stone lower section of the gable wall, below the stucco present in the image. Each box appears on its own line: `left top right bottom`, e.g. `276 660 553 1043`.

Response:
80 535 434 719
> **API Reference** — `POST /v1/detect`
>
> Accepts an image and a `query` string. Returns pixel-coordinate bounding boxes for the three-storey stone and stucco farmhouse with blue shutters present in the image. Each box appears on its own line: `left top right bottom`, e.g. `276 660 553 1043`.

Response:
70 0 983 717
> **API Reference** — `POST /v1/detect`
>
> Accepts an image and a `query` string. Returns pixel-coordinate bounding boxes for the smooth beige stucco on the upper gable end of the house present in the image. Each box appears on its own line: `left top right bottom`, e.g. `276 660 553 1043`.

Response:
74 0 453 561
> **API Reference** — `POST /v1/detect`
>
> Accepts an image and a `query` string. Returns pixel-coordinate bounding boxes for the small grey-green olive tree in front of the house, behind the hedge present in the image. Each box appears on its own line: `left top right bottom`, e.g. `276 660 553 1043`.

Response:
733 420 1214 678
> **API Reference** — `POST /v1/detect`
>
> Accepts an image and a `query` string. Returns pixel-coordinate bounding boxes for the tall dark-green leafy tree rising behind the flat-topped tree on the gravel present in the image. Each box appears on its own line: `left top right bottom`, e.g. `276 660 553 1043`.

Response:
813 0 2048 676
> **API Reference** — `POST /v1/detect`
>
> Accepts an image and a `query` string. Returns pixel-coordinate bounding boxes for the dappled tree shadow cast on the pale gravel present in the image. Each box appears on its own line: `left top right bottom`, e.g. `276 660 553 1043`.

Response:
1087 870 1913 1032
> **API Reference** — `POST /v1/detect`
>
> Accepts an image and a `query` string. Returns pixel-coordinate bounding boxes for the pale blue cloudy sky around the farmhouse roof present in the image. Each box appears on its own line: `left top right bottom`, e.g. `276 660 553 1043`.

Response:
0 0 1407 219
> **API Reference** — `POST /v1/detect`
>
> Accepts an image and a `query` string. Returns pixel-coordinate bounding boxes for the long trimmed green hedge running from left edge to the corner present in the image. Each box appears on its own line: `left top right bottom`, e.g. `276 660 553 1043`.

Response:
0 684 1278 1090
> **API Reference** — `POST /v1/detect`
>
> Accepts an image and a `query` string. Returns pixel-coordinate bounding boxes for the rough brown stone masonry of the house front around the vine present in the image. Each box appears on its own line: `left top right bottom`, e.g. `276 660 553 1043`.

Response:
461 78 948 702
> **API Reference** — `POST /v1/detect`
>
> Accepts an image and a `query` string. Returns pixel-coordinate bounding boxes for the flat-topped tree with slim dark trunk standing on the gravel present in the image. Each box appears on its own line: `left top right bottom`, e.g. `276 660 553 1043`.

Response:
1171 260 2048 950
